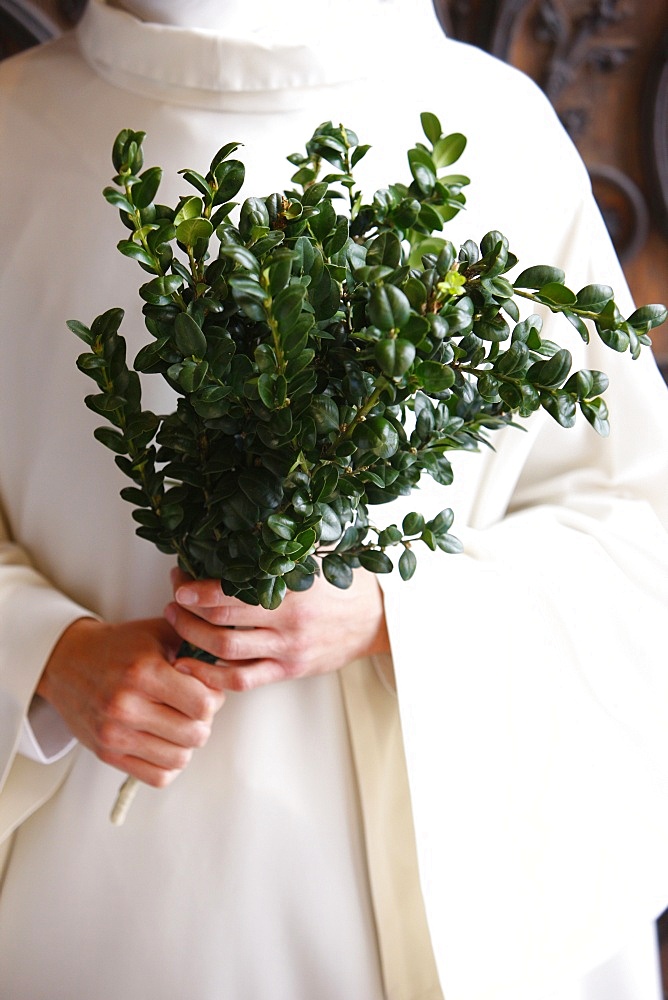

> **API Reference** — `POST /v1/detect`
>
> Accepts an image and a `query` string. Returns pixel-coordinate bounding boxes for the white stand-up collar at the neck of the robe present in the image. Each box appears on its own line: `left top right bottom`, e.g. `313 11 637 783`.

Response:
77 0 439 112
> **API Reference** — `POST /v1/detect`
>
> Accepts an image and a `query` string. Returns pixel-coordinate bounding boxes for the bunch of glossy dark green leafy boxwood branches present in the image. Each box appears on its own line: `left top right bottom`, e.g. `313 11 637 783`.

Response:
69 113 666 608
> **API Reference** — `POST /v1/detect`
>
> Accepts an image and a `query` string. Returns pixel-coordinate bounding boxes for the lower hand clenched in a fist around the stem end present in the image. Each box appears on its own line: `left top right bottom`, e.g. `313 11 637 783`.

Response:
37 618 225 788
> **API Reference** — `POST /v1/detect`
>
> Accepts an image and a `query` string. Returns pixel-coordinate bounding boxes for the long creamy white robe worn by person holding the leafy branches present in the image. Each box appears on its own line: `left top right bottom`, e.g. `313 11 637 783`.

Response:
0 0 668 1000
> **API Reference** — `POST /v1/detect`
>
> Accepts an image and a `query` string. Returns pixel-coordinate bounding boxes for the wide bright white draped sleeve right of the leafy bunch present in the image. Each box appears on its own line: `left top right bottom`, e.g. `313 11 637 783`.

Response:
384 176 668 1000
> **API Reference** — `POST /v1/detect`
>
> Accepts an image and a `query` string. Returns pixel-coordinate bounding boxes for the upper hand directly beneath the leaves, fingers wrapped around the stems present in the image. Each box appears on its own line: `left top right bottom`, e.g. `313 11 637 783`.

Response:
165 570 390 691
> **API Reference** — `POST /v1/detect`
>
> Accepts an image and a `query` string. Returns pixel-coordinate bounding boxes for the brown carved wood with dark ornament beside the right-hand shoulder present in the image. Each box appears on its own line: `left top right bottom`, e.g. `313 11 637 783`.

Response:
434 0 668 374
